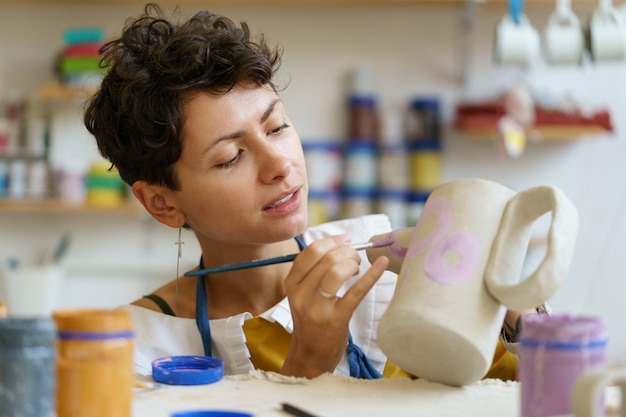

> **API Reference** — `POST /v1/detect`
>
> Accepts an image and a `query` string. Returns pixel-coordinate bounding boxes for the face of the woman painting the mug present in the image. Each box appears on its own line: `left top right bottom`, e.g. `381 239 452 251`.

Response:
174 84 307 244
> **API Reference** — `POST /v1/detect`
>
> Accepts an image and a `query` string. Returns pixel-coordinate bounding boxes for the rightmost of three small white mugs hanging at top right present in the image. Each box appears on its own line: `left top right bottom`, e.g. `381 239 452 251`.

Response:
589 1 626 61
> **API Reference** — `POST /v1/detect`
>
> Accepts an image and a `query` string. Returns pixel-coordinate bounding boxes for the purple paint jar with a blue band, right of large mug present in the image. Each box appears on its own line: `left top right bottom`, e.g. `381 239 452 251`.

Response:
518 314 607 417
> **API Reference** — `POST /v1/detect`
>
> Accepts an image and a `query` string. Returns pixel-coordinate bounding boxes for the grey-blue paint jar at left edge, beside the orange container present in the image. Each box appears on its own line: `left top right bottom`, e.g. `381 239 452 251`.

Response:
0 317 56 417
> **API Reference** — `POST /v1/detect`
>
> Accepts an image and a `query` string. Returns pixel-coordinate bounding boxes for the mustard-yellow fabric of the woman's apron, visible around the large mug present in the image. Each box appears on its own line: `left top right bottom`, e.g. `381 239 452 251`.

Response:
243 317 518 381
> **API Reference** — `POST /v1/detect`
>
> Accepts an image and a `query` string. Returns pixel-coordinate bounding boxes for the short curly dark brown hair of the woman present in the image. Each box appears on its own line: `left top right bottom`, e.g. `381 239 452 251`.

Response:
84 3 282 190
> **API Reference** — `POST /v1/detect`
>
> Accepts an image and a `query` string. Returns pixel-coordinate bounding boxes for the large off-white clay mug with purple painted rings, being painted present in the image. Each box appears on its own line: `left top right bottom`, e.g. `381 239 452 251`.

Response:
368 179 578 386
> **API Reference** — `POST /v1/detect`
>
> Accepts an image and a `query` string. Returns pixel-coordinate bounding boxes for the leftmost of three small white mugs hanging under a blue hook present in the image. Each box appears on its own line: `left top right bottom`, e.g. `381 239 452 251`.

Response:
495 15 540 66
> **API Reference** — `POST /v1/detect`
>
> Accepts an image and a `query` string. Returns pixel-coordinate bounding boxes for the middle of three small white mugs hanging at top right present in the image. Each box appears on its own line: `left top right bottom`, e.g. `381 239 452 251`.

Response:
544 8 585 65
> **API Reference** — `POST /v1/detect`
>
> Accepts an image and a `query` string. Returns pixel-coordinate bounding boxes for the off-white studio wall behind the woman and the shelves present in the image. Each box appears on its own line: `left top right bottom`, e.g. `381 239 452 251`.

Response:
0 1 626 362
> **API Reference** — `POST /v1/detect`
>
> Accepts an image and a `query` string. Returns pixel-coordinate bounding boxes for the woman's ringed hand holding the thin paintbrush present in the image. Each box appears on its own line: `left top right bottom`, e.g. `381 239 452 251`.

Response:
281 235 389 378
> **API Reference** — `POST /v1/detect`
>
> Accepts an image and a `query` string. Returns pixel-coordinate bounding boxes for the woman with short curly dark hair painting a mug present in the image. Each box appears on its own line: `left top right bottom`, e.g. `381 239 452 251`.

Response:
85 5 515 378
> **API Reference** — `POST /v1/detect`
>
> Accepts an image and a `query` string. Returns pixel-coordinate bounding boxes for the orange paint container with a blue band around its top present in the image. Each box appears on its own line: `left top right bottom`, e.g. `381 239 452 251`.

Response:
53 309 134 417
